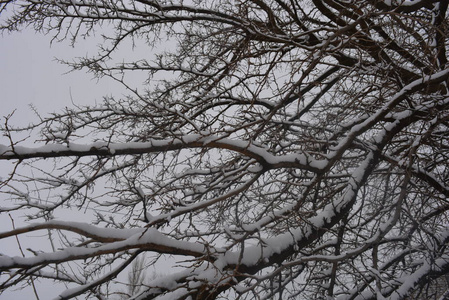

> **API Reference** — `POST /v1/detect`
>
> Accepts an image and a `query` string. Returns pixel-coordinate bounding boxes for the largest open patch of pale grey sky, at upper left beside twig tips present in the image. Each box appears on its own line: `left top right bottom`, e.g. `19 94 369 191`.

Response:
0 30 115 123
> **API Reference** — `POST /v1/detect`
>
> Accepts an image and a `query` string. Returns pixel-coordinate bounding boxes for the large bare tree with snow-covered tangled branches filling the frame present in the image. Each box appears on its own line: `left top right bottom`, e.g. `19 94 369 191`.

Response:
0 0 449 300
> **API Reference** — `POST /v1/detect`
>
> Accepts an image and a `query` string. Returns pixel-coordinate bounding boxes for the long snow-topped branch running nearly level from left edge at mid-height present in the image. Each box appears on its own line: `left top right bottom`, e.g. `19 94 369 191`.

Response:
0 134 327 172
